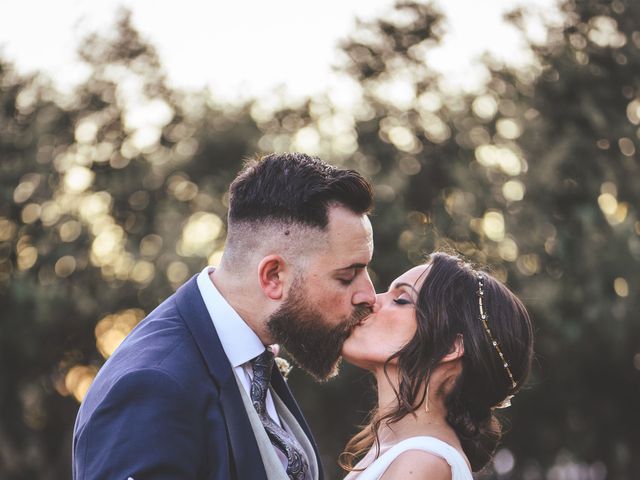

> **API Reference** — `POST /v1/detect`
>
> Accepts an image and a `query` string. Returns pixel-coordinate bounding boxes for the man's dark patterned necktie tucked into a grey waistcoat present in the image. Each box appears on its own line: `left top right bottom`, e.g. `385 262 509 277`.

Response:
251 349 309 480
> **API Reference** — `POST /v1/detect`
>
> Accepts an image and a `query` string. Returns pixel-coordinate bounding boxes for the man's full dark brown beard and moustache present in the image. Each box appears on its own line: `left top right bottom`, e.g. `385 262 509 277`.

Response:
267 279 371 381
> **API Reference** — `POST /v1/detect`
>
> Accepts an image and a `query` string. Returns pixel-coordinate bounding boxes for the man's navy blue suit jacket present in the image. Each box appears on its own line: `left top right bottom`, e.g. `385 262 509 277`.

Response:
73 276 323 480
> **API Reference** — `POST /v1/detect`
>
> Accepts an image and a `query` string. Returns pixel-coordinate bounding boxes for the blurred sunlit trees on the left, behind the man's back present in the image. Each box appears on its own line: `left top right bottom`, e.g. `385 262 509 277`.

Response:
0 12 260 479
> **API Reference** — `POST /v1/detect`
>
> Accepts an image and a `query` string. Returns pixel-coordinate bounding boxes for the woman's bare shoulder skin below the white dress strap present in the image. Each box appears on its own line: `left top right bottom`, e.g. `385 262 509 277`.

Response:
381 450 451 480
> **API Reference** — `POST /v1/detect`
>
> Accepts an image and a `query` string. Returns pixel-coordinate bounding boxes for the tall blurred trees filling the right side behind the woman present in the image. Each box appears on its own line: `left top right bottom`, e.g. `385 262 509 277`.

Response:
282 0 640 479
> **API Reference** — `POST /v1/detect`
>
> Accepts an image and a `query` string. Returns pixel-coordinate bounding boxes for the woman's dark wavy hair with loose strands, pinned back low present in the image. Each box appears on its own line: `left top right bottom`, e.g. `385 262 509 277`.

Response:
339 252 533 472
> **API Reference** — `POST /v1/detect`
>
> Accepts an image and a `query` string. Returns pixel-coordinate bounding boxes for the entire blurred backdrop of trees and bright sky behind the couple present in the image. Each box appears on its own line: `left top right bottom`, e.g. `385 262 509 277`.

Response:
0 0 640 480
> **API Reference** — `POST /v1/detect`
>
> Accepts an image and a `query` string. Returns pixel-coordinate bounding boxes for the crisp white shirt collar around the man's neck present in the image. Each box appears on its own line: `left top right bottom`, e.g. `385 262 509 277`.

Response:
197 267 265 368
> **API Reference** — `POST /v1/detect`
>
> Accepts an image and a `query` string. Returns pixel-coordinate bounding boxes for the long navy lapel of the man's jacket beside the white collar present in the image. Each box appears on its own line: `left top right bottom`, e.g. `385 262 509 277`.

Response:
175 275 268 479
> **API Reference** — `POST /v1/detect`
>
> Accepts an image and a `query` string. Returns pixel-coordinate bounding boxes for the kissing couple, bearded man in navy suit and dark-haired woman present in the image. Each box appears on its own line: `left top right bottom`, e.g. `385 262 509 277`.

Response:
73 153 533 480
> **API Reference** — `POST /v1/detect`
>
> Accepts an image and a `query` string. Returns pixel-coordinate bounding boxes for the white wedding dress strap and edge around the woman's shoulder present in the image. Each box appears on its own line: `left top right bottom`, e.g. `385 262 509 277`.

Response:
357 437 473 480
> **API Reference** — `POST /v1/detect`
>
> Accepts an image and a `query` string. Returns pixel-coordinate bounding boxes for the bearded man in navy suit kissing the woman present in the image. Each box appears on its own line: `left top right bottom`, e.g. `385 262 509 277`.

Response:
73 153 375 480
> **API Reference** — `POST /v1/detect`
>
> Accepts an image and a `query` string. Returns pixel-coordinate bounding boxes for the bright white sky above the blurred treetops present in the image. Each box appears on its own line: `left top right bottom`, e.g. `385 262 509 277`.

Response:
0 0 558 102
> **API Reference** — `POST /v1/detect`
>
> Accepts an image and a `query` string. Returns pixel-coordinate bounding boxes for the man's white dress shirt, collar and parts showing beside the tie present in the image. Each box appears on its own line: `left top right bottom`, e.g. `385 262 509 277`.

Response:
197 267 288 468
